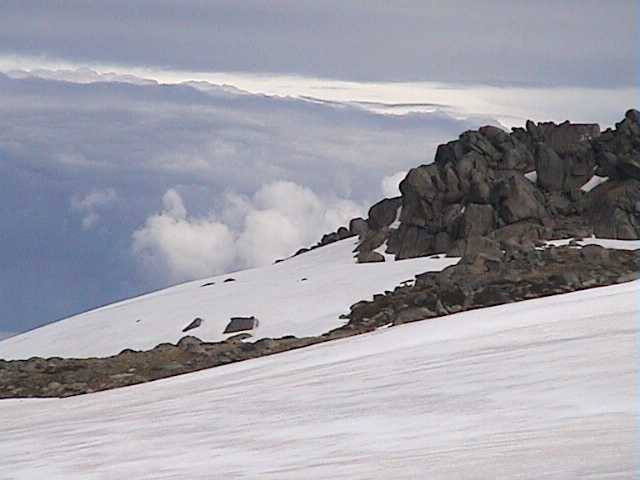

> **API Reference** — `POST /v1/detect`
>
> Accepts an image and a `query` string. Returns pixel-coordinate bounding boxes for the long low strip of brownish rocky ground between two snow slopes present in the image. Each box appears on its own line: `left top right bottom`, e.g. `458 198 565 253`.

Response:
0 242 640 398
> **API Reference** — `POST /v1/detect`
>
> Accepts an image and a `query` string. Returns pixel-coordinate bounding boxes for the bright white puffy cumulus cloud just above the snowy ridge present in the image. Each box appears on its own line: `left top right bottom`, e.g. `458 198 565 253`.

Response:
132 182 364 282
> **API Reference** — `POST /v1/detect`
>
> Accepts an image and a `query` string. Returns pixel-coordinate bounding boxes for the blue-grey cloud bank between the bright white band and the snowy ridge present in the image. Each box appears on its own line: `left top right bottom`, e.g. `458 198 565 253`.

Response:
0 75 487 338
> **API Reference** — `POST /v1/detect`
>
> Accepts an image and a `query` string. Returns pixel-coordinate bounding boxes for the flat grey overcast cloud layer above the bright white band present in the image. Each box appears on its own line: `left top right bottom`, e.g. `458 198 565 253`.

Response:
0 0 640 86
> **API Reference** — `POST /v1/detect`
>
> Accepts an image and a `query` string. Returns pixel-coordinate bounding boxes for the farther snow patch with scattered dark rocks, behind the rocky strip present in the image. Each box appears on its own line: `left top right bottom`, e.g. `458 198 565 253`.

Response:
0 239 457 359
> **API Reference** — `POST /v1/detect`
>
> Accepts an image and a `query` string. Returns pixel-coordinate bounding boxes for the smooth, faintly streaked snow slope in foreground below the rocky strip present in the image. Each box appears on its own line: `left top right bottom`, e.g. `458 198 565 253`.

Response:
0 280 640 480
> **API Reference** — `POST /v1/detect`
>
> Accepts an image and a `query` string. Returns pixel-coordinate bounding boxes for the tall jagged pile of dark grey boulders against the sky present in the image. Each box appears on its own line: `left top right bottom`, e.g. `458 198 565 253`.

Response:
306 110 640 262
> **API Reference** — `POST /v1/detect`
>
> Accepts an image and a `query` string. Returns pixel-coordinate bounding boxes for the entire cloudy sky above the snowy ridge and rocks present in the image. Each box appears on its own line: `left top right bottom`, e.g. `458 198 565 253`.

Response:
0 0 640 338
